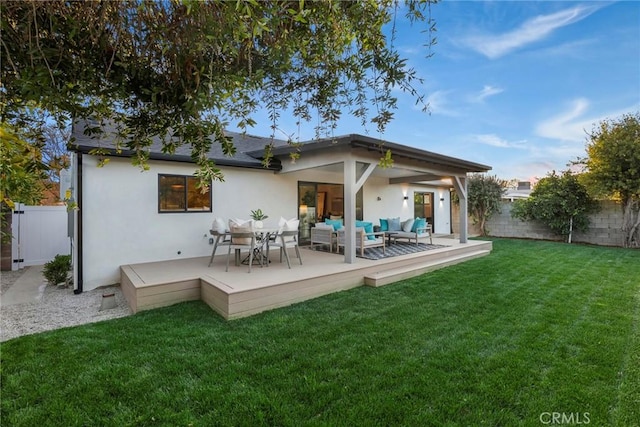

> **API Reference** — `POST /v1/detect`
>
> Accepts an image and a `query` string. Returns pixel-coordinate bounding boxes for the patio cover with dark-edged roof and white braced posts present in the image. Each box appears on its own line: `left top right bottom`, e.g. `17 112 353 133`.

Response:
258 134 491 264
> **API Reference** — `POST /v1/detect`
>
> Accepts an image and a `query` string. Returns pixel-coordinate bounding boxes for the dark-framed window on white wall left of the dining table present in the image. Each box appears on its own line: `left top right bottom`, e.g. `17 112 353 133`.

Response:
158 174 212 213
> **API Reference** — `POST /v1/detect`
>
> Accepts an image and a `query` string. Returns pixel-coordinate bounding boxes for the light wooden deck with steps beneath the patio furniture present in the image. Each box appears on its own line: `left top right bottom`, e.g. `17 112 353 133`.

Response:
120 238 492 319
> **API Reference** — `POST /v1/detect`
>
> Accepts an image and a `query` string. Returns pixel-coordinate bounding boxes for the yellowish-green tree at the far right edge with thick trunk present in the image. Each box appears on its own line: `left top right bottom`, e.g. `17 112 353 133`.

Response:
580 112 640 247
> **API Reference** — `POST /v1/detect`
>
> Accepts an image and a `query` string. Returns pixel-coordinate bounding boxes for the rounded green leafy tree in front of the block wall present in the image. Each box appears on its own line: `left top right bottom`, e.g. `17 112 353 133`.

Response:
511 171 597 243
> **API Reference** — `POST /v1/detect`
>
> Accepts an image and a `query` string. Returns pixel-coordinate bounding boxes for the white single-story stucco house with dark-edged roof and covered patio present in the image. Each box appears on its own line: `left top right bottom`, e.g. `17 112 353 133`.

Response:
71 123 490 292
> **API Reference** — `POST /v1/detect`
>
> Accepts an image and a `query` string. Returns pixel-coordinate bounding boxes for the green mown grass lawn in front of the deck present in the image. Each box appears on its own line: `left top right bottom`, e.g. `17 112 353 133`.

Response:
0 240 640 427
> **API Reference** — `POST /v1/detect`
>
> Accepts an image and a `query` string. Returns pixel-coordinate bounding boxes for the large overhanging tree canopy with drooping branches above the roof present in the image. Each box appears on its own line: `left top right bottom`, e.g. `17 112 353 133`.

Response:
0 0 435 184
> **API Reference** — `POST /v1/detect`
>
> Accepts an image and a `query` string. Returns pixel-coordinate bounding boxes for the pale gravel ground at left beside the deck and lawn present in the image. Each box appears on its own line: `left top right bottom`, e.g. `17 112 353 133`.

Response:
0 267 131 342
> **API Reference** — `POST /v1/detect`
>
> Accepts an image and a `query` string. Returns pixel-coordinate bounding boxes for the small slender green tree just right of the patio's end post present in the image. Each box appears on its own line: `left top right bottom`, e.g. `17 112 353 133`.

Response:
467 174 507 236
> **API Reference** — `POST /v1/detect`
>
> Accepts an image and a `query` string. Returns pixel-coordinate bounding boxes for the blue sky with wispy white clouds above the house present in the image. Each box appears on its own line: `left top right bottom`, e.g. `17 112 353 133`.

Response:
232 0 640 180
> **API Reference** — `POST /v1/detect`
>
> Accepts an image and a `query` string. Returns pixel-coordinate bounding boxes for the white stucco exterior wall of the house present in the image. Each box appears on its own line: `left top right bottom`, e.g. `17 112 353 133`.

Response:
81 155 450 290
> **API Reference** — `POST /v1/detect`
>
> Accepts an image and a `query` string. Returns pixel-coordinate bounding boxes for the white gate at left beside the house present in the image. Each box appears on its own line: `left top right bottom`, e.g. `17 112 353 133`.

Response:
11 204 71 270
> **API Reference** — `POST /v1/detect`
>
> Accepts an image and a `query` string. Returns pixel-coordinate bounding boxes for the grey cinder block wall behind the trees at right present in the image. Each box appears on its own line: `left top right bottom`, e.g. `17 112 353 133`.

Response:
453 201 624 246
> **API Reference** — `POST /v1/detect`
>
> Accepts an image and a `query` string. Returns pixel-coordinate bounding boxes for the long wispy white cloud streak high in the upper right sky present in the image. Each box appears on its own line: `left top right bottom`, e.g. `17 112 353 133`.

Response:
463 5 602 59
